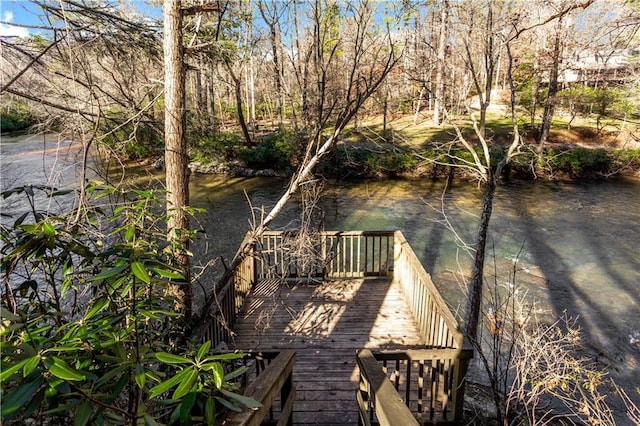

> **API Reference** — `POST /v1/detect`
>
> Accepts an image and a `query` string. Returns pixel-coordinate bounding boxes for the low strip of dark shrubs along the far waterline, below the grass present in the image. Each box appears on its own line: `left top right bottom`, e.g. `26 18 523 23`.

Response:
180 143 640 181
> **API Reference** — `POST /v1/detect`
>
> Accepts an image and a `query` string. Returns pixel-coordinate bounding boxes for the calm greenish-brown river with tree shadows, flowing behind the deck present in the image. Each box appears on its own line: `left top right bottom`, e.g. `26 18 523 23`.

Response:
0 138 640 416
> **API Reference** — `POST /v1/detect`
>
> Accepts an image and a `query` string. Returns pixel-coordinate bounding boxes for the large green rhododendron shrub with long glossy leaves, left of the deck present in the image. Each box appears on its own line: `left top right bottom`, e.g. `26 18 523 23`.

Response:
0 186 259 426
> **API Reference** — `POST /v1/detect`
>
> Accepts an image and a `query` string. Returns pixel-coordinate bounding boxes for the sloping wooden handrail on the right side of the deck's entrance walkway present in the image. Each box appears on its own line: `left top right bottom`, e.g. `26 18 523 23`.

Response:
356 349 419 426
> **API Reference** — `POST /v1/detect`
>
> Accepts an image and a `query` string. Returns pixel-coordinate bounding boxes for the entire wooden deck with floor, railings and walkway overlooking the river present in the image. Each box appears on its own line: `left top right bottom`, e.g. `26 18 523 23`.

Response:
208 231 473 426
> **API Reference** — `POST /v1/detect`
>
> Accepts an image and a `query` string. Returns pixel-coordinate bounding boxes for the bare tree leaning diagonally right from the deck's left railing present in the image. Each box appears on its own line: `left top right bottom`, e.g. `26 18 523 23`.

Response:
200 0 400 318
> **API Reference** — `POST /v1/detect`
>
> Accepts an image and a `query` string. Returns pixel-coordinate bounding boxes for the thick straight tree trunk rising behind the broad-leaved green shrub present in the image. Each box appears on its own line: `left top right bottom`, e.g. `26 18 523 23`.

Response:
163 0 192 319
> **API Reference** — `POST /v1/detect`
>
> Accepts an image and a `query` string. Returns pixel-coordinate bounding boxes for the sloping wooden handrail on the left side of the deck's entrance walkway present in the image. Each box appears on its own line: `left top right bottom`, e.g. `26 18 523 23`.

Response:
225 349 296 426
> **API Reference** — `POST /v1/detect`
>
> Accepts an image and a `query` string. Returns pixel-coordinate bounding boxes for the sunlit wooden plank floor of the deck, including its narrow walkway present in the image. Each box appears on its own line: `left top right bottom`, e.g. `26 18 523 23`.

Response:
230 277 424 425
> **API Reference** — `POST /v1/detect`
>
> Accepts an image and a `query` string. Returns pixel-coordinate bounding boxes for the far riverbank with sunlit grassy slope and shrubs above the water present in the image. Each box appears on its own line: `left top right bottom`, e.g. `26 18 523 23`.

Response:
181 116 640 181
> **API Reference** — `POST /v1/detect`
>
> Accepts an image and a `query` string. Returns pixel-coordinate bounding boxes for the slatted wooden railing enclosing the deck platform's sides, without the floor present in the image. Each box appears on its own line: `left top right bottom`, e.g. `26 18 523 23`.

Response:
204 231 472 424
